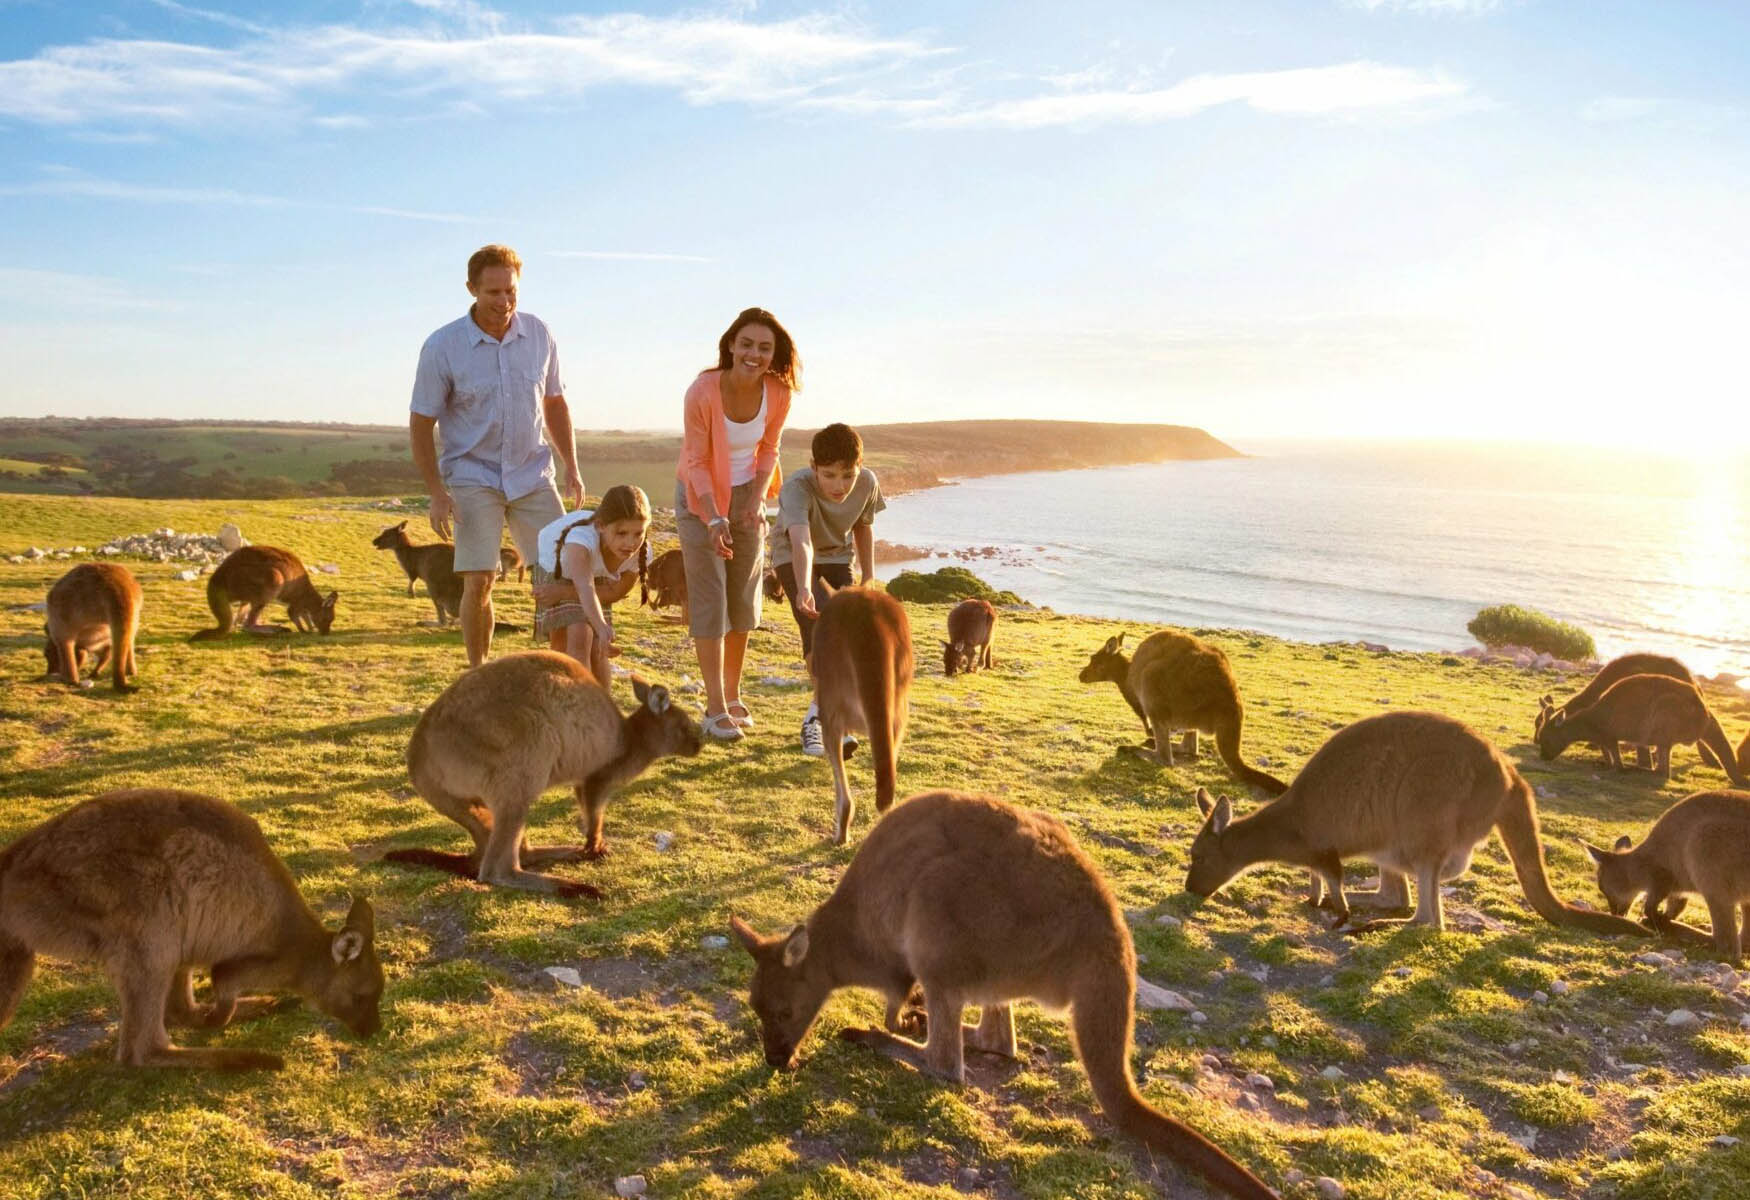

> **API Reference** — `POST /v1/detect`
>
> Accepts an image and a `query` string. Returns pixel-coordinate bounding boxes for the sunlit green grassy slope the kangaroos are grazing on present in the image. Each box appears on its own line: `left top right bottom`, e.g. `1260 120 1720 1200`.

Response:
0 497 1750 1200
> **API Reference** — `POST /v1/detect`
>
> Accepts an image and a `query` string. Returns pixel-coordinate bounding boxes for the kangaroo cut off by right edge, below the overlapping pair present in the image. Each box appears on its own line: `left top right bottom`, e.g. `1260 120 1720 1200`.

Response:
1586 792 1750 966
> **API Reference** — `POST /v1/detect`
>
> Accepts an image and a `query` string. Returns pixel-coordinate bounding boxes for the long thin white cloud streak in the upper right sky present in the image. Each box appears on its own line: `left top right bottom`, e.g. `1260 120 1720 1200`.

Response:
921 63 1468 129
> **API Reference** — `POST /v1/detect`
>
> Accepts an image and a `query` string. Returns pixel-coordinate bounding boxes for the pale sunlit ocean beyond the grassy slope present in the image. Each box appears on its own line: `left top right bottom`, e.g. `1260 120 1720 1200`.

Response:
875 443 1750 675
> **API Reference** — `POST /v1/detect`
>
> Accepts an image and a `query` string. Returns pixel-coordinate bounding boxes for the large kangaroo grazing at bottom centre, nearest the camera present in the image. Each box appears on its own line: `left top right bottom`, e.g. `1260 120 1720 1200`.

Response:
730 790 1276 1200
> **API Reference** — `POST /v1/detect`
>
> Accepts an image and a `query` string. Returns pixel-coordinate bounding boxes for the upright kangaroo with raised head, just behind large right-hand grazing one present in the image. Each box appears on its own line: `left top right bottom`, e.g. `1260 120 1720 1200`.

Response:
1082 630 1288 796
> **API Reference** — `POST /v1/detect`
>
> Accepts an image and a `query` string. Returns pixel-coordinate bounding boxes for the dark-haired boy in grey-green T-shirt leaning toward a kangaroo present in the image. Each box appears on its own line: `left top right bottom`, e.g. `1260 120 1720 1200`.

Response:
772 425 887 757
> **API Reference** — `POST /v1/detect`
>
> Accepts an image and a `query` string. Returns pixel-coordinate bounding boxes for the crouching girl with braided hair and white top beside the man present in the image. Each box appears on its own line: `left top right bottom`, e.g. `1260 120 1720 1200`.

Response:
536 483 651 687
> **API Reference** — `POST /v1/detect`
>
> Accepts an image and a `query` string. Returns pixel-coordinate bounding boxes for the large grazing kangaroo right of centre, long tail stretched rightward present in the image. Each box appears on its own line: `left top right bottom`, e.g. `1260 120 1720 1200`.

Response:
1185 712 1647 934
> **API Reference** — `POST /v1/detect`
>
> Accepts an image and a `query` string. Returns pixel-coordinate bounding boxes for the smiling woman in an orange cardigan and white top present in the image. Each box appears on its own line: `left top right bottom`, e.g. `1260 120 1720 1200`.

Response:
674 308 802 742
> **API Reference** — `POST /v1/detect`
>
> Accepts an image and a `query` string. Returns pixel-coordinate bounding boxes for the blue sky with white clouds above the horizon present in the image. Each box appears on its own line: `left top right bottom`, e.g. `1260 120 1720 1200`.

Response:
0 0 1750 453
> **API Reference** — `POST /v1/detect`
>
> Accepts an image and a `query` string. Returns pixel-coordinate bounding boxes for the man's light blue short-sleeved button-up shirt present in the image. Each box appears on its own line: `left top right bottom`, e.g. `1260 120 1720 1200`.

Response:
413 313 565 500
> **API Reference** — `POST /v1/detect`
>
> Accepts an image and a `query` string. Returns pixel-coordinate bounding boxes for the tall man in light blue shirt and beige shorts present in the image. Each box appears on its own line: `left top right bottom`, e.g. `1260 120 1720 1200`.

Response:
408 245 583 666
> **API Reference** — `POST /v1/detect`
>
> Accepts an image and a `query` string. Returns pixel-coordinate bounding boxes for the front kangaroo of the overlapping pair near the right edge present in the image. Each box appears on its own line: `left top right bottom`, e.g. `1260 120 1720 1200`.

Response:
1537 675 1750 787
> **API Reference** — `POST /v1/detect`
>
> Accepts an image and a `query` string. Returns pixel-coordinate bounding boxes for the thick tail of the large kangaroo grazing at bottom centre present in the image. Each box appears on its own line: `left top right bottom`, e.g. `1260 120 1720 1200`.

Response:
1069 967 1276 1200
